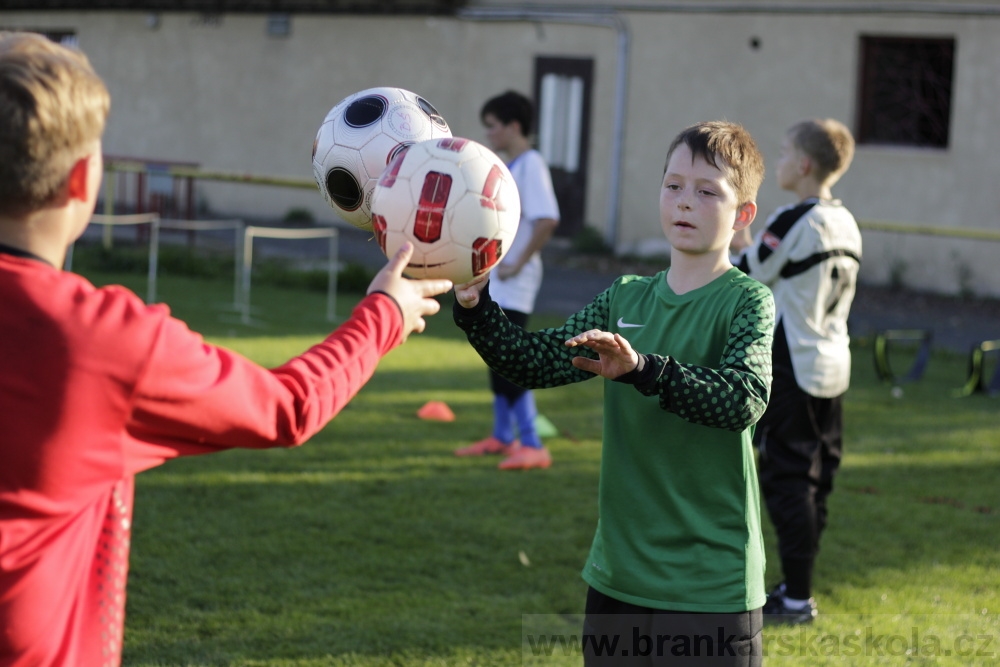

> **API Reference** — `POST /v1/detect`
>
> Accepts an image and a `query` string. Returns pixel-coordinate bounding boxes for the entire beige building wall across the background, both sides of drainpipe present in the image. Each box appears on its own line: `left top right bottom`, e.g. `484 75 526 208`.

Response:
0 0 1000 296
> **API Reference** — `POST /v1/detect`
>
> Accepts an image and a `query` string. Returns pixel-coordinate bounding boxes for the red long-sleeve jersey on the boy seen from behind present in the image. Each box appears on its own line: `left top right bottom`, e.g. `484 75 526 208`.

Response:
0 254 402 667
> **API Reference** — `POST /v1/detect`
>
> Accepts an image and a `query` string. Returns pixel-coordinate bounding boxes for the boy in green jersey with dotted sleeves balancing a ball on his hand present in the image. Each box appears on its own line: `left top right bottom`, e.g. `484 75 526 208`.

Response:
454 121 774 666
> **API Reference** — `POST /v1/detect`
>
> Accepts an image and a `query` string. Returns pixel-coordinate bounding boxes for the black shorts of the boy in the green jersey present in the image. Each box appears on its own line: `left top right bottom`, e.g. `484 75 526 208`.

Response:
582 588 764 667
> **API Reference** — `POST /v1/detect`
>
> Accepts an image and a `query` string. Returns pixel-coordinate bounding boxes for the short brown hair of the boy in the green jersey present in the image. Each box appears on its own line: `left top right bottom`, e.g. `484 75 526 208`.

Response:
663 120 764 206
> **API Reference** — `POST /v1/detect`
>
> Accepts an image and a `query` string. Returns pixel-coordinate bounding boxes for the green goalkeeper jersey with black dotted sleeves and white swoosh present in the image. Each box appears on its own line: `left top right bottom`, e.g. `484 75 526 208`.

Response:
454 269 774 612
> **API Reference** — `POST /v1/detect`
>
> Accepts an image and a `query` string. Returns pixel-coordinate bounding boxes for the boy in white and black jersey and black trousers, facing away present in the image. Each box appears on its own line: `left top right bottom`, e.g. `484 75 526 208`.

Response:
733 119 861 623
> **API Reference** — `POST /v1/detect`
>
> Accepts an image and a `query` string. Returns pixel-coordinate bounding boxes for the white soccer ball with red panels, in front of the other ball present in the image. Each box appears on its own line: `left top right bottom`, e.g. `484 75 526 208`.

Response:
372 137 521 285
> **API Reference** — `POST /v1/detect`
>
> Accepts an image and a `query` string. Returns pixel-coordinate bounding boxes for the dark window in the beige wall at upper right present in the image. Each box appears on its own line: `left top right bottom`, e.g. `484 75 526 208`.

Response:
857 36 955 148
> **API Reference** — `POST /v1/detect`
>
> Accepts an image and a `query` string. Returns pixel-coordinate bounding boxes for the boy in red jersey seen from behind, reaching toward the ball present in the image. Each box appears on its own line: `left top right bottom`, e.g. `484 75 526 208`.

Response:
0 32 451 667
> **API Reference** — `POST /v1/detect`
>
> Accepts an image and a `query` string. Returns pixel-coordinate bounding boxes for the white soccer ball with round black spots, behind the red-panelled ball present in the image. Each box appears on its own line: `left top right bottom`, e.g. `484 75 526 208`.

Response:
312 87 451 230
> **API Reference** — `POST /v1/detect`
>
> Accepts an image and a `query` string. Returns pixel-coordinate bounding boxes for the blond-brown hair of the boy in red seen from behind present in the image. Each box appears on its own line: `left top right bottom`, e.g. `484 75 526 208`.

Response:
0 32 111 217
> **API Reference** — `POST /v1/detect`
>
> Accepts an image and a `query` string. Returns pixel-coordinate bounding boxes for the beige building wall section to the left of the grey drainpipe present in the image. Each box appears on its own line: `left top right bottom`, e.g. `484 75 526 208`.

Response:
0 12 615 243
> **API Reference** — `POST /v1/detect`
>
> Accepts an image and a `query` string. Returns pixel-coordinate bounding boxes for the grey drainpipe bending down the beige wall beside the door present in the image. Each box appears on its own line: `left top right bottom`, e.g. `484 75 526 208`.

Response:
457 7 632 249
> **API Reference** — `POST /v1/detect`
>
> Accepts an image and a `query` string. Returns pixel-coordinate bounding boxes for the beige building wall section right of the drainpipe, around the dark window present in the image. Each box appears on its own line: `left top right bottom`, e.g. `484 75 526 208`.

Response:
620 7 1000 296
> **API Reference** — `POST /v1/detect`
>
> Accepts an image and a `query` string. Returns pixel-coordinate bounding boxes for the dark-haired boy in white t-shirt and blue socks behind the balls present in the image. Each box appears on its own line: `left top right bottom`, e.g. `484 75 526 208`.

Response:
455 91 559 470
